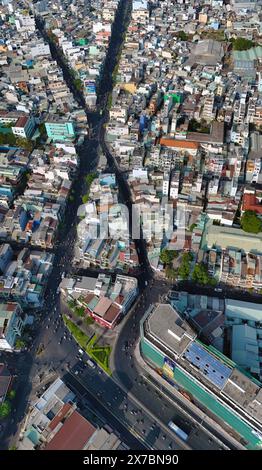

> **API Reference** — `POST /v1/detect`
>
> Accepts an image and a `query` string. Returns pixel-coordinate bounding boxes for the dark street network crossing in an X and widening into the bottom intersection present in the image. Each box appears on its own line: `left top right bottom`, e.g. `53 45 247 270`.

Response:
0 0 261 450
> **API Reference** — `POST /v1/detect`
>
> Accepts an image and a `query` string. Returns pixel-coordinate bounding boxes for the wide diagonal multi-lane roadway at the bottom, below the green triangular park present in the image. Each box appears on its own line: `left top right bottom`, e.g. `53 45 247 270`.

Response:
66 366 183 450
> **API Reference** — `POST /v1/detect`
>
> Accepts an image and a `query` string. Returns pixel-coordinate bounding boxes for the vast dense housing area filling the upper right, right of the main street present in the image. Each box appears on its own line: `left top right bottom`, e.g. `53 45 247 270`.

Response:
106 0 262 289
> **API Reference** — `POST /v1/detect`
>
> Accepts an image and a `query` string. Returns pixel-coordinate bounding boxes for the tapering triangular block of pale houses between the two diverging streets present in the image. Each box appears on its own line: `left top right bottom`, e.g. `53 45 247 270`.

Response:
75 173 138 272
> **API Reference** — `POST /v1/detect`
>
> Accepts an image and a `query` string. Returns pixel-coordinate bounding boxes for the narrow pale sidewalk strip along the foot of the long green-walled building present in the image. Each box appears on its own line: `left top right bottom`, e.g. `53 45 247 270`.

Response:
134 342 246 450
